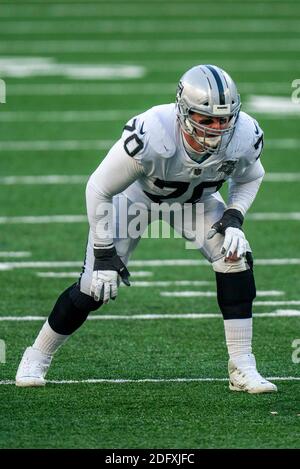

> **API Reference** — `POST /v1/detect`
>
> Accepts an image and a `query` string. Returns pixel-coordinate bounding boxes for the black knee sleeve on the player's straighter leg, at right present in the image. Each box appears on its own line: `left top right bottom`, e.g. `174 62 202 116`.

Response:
216 269 256 319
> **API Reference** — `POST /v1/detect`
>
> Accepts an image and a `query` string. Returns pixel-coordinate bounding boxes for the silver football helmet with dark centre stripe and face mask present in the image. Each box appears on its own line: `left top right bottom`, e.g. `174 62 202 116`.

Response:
176 65 241 153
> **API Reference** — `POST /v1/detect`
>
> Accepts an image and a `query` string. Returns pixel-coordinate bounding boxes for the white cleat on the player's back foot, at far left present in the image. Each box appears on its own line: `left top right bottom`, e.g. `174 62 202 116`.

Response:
16 347 52 387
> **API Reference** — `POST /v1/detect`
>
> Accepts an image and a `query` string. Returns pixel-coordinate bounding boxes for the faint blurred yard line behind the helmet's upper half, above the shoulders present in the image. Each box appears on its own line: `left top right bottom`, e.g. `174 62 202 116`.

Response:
3 82 291 95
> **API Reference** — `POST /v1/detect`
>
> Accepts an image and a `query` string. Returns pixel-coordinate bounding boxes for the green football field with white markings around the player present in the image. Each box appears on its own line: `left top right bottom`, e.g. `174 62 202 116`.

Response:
0 0 300 449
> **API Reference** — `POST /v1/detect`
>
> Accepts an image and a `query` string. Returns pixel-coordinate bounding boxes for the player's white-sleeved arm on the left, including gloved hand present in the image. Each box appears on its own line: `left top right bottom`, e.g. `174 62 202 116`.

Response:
86 140 143 303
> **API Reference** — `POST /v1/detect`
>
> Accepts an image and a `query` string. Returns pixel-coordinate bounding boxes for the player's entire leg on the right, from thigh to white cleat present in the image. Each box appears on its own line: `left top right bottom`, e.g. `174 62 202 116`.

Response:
175 193 277 393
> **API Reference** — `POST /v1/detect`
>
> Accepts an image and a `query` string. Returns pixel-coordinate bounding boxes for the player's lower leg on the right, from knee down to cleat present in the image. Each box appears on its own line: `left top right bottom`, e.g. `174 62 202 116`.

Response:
212 252 277 394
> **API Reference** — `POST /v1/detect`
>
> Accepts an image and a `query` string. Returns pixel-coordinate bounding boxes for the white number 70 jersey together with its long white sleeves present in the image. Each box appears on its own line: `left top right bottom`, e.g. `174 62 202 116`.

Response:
86 104 264 244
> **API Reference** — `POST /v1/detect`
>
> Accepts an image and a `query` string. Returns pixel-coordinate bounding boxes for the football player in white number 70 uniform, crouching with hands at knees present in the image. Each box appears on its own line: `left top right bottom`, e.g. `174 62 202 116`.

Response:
16 65 277 393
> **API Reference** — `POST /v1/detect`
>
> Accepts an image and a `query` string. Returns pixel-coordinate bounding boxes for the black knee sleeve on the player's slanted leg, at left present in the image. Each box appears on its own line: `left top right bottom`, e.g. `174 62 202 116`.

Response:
48 283 103 335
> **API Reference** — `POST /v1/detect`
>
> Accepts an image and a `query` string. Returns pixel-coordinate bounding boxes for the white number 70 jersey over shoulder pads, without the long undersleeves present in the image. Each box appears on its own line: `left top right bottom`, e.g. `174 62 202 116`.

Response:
121 104 264 206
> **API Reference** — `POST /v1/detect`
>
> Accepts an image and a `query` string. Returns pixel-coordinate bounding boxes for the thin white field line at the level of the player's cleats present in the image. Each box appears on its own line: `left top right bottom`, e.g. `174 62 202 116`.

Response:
0 376 300 385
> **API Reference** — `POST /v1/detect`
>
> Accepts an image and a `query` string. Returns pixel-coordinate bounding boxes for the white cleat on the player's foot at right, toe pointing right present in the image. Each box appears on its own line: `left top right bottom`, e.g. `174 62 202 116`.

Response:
228 354 277 394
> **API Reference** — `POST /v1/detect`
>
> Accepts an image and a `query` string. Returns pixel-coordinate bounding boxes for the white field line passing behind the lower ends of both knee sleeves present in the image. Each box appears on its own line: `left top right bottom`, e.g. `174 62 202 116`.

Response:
0 308 300 322
